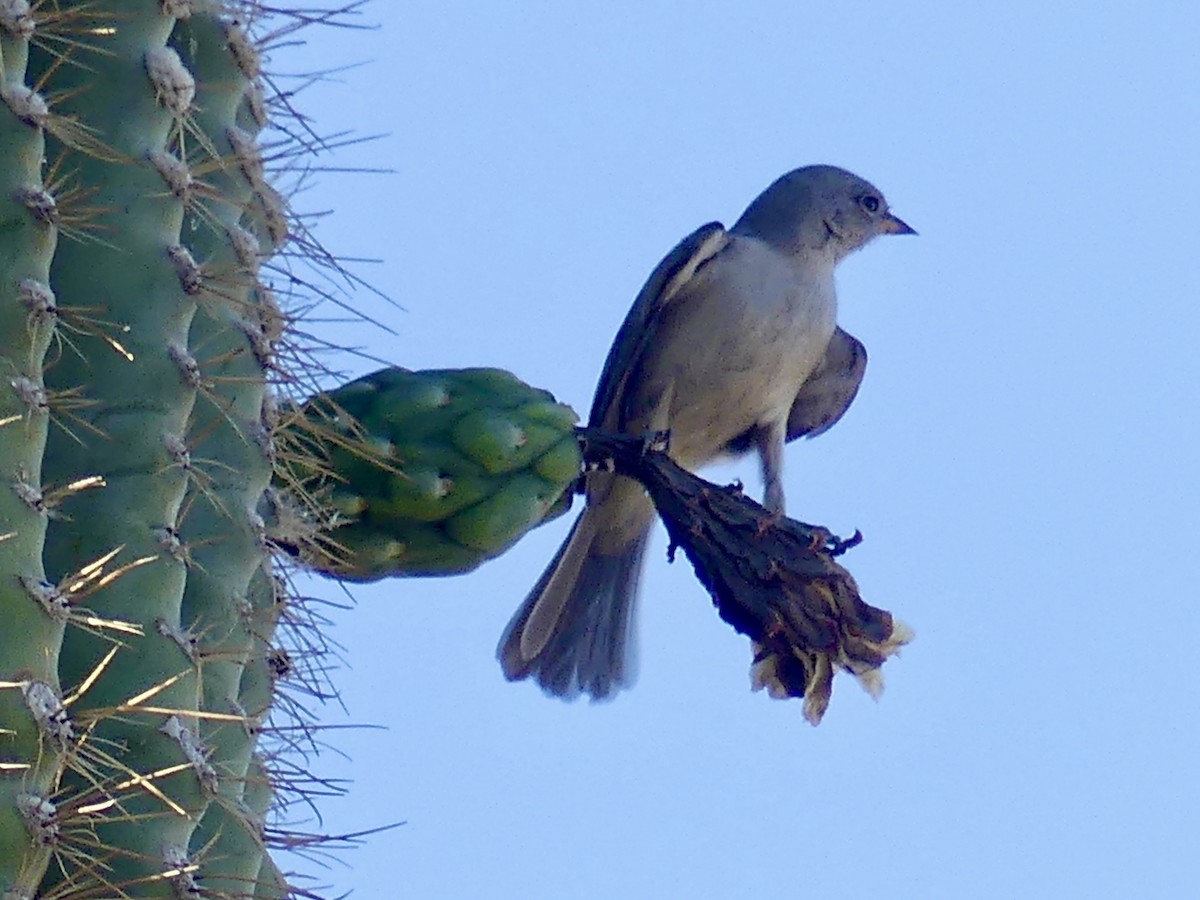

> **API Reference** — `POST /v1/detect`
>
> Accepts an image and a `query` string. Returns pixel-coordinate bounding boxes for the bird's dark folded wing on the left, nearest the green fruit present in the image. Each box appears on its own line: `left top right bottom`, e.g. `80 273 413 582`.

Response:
588 222 730 428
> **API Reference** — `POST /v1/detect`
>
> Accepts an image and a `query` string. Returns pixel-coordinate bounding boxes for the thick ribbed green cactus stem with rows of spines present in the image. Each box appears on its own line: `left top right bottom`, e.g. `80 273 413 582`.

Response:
0 0 338 900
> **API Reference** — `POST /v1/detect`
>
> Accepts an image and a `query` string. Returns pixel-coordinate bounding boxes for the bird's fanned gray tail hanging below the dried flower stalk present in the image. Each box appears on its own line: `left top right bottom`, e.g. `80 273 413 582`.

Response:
497 504 654 700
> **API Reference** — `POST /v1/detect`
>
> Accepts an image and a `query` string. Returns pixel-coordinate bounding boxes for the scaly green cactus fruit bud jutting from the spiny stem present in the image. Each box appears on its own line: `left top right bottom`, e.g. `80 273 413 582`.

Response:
295 368 581 581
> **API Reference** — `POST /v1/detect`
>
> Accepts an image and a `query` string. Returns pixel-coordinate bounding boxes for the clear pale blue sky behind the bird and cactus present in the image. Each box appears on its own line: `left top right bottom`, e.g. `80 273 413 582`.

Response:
280 2 1200 900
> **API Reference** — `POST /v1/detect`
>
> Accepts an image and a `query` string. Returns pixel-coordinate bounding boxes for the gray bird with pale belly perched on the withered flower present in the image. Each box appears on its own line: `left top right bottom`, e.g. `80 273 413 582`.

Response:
497 166 916 700
